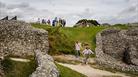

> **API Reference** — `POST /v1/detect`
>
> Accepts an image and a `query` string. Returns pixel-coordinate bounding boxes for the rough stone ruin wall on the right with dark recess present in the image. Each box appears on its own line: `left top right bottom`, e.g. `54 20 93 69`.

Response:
95 28 138 72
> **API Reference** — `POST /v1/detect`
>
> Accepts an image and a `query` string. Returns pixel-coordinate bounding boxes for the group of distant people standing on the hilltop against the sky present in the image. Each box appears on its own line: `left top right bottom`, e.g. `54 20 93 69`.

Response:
37 17 66 27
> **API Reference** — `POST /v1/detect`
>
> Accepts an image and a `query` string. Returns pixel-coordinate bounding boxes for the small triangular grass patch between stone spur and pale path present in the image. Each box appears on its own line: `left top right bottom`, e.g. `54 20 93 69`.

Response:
56 64 86 77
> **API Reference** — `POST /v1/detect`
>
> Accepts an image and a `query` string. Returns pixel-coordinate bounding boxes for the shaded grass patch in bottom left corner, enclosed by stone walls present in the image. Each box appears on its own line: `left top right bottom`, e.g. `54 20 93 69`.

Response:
2 57 36 77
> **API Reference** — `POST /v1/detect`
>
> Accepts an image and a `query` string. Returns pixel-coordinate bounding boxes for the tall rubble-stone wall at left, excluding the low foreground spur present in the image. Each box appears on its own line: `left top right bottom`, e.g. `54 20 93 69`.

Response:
0 20 48 56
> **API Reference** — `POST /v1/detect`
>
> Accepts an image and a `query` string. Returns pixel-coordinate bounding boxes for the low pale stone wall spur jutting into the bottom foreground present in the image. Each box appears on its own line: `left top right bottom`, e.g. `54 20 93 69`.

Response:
30 50 59 77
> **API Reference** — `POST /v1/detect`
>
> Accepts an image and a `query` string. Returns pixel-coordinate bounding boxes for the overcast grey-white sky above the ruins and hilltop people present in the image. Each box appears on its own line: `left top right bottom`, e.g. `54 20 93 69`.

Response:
0 0 138 26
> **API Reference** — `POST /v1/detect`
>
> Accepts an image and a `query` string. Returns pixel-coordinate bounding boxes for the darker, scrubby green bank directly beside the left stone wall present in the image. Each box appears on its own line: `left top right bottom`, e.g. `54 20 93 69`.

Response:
32 24 74 55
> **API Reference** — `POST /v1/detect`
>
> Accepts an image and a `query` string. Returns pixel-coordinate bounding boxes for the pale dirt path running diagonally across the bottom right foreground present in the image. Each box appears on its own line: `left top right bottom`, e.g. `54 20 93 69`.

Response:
59 63 129 77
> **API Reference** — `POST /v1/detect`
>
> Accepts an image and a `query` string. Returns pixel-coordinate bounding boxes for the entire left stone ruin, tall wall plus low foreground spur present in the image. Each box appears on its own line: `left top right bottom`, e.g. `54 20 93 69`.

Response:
0 20 59 77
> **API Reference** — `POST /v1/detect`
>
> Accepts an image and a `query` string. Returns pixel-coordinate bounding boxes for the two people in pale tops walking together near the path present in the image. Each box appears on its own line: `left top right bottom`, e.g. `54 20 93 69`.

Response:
75 41 94 64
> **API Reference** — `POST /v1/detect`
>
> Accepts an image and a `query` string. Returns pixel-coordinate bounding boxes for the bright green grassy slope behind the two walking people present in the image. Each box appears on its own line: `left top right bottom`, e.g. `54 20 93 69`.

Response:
62 26 106 50
